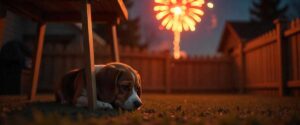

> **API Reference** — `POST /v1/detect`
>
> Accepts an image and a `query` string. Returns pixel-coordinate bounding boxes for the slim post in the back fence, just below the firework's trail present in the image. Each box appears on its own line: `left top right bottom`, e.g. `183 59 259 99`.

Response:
165 51 171 94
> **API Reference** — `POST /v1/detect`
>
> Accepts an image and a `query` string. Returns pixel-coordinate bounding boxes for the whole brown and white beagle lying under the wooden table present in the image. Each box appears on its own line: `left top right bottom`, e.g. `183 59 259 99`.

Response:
55 63 142 110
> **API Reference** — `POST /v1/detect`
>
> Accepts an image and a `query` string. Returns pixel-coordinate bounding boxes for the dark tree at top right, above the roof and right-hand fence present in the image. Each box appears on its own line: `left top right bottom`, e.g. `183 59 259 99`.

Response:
250 0 288 22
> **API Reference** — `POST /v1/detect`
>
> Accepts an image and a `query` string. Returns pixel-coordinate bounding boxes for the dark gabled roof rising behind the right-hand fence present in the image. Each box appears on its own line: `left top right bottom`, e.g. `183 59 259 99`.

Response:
218 21 275 52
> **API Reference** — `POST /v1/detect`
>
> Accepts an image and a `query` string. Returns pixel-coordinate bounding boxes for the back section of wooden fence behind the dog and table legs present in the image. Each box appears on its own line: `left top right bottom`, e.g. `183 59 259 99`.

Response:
22 44 235 93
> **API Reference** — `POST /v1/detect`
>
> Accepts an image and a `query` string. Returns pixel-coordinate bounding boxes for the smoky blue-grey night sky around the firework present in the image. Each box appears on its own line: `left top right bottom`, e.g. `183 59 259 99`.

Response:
129 0 252 55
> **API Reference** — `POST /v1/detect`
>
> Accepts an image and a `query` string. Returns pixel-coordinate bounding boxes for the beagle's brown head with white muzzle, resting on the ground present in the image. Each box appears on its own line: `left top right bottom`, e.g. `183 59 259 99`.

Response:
96 63 142 110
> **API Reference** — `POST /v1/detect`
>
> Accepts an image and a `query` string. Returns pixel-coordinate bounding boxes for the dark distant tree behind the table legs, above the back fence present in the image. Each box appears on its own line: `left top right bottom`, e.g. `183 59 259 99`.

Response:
94 0 146 48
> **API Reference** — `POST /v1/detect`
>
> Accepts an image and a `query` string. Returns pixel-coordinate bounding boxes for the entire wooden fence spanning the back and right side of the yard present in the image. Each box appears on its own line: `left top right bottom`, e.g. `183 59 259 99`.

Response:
20 19 300 95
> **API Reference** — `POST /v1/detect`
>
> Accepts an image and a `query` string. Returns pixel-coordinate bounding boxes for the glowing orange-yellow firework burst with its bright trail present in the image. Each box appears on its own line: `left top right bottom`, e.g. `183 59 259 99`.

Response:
154 0 213 59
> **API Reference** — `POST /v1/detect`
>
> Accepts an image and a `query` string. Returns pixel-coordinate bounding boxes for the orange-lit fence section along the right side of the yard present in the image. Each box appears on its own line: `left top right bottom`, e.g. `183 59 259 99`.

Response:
235 19 300 95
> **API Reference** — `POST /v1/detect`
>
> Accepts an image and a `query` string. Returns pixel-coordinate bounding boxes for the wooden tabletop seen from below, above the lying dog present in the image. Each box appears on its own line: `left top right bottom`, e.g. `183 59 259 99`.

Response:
0 0 128 23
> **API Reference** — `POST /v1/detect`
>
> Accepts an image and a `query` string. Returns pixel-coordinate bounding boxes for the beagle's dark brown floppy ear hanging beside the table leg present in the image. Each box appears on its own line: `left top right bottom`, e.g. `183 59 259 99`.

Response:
96 65 122 102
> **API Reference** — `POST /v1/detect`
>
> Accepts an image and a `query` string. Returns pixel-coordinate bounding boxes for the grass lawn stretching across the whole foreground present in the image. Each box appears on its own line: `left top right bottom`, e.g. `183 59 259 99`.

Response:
0 94 300 125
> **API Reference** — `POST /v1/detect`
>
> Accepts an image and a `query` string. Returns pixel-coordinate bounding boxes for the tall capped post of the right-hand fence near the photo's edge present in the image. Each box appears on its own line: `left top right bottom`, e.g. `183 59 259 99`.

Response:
274 19 287 96
